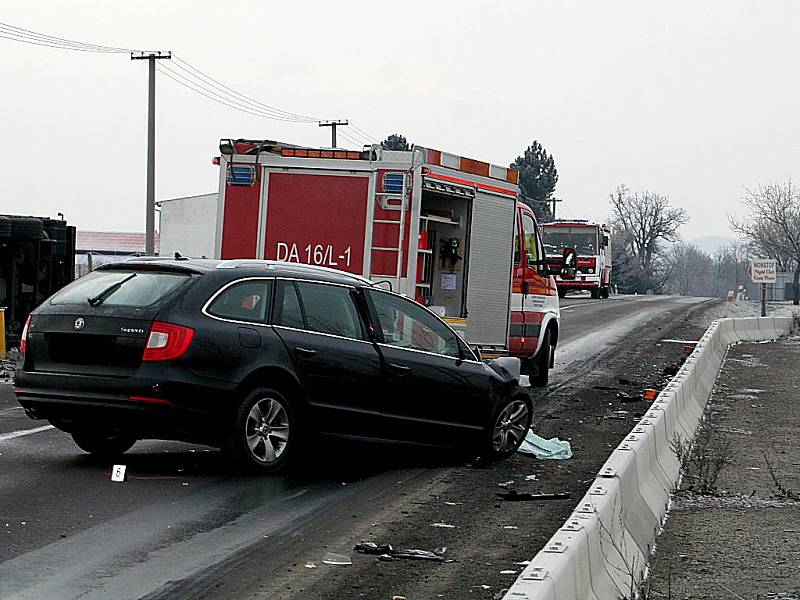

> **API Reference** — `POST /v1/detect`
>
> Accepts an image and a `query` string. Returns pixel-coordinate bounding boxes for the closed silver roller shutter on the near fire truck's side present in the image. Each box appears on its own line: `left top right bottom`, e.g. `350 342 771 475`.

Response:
467 191 516 348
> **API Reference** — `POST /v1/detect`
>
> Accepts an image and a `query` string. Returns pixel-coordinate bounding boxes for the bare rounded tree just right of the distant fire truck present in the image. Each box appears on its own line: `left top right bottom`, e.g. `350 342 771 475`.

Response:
610 185 689 292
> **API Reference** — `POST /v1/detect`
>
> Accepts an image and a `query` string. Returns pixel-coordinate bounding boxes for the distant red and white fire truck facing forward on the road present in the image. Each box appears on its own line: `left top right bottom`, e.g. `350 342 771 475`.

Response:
542 219 611 298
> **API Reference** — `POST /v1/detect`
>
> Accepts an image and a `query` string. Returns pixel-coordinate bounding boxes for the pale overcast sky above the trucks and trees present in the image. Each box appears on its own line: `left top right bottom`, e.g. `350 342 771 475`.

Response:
0 0 800 243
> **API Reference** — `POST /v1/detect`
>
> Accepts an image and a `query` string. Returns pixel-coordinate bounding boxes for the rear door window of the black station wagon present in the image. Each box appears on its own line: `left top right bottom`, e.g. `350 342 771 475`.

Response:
297 282 366 340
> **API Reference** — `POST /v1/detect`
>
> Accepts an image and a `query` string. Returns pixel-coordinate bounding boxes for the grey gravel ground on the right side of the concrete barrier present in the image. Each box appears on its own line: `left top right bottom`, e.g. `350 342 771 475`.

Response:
650 338 800 600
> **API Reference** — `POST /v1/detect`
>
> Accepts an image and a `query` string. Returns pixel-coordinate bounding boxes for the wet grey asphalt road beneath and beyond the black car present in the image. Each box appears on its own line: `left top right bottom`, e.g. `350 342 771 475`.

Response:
0 296 702 600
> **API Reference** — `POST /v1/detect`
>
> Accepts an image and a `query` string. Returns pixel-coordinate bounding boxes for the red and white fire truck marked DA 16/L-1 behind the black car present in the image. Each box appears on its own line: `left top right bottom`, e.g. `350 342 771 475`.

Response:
206 139 559 385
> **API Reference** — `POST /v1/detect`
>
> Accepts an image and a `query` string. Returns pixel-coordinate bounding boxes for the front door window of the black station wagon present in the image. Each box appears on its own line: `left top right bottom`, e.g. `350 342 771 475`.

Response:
369 291 461 358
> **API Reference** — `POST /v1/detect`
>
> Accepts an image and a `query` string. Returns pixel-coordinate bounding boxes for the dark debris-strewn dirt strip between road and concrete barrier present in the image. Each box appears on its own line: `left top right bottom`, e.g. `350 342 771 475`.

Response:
191 303 722 600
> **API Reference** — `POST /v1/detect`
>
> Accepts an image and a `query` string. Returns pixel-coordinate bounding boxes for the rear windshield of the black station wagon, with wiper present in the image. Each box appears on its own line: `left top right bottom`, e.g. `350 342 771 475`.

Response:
50 270 189 306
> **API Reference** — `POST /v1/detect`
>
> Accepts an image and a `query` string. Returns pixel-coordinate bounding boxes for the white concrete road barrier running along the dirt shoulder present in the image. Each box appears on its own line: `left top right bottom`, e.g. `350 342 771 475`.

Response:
503 317 793 600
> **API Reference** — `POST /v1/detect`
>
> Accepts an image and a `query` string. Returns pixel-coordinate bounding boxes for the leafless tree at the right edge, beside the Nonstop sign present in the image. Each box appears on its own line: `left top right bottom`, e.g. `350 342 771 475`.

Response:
730 180 800 305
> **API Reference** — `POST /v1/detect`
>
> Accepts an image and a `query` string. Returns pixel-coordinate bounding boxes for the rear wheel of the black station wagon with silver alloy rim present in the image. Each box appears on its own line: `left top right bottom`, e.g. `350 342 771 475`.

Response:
225 387 300 473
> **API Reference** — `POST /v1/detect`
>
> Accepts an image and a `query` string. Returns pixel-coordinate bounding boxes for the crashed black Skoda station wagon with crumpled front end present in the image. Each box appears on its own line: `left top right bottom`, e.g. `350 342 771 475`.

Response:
15 257 532 472
